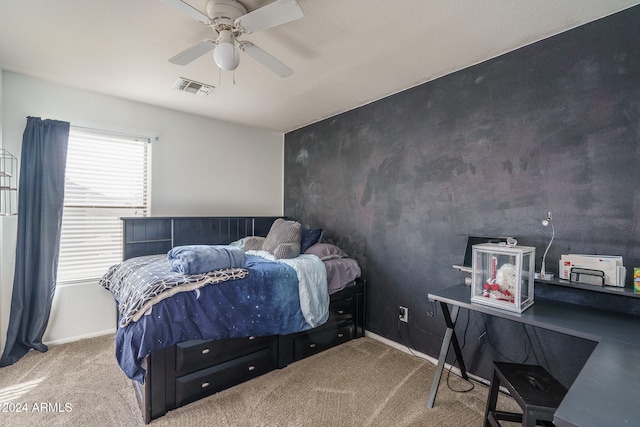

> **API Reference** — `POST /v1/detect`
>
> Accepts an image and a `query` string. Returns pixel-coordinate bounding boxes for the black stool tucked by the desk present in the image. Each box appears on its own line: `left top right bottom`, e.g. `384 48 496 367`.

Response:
484 362 567 427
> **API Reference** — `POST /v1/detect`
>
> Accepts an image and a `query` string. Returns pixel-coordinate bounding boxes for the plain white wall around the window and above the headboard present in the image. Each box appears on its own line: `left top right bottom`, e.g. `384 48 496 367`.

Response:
0 71 284 348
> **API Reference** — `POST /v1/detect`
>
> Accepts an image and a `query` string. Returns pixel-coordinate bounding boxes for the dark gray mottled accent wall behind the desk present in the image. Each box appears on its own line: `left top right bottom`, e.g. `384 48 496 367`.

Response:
284 6 640 386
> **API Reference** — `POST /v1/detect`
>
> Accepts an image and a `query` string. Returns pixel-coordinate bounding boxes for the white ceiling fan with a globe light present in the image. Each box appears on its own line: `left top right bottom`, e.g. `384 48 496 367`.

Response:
160 0 304 77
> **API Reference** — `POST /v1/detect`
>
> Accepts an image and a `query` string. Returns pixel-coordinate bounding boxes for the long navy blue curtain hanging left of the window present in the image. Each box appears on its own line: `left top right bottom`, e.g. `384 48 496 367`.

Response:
0 117 69 366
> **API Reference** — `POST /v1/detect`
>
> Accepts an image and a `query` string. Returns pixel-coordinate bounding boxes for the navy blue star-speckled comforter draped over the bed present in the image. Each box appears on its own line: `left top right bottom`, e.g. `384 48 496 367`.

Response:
110 255 329 383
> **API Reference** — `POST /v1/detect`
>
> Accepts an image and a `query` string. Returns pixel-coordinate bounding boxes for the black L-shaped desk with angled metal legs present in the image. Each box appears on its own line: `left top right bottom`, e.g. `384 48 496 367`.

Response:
427 284 640 427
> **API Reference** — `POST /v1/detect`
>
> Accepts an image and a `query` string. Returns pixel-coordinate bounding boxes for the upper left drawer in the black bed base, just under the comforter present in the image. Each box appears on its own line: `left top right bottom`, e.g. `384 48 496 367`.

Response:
176 336 277 376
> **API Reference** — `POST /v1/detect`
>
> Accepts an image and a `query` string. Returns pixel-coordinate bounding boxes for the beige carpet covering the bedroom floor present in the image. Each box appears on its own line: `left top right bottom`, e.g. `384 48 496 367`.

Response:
0 336 513 427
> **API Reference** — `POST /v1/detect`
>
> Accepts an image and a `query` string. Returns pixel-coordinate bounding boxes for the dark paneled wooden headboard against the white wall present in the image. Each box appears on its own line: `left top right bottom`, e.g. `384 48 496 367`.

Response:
121 216 280 260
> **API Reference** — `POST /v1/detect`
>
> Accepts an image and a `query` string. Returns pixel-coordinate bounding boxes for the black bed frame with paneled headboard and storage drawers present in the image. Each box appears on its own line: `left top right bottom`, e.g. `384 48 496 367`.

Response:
122 217 365 423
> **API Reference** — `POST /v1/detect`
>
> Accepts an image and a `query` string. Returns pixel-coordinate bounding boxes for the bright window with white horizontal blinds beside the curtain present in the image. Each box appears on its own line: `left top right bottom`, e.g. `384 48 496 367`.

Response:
57 127 150 284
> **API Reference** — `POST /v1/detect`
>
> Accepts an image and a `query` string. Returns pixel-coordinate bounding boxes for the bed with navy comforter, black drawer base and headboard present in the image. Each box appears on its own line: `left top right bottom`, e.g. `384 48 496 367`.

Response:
103 217 365 423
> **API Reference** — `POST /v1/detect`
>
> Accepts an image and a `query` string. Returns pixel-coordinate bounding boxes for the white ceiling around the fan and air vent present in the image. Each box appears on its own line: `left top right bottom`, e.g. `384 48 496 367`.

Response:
0 0 640 133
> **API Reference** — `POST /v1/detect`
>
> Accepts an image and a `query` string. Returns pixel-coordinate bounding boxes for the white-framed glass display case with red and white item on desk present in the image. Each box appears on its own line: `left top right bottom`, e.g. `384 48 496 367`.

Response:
471 243 536 313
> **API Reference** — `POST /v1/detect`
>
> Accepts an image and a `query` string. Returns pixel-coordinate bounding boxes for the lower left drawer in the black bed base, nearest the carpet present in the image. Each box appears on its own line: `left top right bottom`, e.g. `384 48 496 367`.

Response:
176 348 276 407
